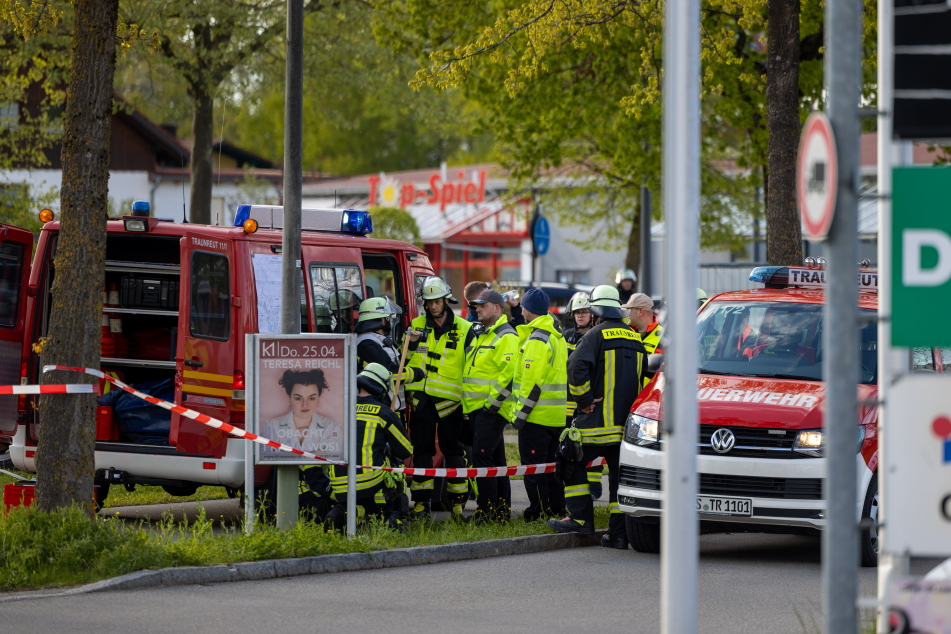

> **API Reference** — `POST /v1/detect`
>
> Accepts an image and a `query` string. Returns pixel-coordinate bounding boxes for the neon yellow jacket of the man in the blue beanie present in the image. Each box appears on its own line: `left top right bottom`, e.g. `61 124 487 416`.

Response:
510 315 568 427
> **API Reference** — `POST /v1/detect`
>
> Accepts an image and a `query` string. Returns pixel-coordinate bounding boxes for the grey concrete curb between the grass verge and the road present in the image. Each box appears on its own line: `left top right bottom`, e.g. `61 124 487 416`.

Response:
0 530 607 603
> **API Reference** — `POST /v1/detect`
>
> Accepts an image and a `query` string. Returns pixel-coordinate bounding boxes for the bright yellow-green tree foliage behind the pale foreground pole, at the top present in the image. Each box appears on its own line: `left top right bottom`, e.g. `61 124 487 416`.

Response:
375 0 874 262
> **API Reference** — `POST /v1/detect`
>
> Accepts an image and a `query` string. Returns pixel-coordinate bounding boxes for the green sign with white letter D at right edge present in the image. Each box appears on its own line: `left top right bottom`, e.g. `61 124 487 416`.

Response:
888 167 951 348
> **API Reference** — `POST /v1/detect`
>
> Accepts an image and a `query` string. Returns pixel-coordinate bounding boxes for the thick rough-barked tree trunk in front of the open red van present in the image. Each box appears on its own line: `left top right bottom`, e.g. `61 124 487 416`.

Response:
36 0 119 514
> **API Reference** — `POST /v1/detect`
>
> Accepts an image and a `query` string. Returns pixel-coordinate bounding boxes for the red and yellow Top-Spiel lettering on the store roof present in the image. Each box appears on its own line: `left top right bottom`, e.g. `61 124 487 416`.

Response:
367 170 486 211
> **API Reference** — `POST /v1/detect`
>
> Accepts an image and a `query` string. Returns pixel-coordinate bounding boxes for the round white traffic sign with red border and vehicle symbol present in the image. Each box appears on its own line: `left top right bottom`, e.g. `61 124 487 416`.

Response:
796 112 838 240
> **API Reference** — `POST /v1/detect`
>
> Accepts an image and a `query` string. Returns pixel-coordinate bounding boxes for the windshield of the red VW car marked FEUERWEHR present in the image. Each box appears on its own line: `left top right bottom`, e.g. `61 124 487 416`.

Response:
697 302 878 384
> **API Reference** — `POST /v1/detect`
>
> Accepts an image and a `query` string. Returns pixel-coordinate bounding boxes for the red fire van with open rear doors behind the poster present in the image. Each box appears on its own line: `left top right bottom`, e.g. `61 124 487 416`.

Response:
0 203 433 504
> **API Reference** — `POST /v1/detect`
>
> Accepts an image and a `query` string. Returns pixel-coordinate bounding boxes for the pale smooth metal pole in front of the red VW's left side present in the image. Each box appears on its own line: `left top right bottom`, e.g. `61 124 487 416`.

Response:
660 0 700 634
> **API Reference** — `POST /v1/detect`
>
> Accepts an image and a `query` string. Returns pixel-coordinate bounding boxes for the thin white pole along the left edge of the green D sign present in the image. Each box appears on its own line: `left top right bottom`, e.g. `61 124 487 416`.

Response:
877 0 909 620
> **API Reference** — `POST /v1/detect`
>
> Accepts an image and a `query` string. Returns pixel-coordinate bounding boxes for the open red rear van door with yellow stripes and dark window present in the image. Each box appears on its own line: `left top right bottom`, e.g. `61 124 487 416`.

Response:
169 232 238 457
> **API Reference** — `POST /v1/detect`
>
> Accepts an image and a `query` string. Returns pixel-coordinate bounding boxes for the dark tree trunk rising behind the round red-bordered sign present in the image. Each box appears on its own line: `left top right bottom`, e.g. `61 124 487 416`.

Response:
766 0 802 265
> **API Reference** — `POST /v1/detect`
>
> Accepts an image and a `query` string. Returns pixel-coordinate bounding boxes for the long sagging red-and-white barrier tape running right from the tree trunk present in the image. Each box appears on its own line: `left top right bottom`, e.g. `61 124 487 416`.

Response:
41 365 605 478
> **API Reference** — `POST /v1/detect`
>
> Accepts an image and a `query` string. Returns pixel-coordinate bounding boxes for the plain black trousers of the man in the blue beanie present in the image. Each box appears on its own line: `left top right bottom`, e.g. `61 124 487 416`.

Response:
518 423 564 522
